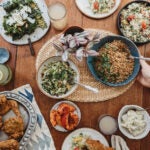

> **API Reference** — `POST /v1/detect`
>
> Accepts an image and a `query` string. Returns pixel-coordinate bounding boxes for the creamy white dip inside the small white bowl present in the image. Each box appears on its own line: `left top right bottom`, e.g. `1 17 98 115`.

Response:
121 110 146 136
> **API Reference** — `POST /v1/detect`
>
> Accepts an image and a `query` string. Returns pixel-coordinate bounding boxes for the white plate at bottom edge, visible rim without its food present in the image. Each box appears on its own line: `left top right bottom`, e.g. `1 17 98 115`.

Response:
61 128 109 150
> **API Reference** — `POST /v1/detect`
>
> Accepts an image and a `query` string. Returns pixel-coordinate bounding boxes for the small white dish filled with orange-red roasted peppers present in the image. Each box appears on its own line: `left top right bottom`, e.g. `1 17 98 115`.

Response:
50 101 81 132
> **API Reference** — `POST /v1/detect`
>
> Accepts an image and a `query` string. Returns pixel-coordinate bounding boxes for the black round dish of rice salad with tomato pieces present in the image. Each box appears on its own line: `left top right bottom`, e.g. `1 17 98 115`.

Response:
117 0 150 44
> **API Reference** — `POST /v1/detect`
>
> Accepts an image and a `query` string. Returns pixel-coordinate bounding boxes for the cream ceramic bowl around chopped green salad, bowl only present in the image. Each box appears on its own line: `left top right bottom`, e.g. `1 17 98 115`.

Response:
36 56 79 99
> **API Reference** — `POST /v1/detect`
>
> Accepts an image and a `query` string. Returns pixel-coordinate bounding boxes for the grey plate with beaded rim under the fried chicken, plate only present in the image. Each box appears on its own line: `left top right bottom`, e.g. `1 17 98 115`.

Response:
0 91 37 150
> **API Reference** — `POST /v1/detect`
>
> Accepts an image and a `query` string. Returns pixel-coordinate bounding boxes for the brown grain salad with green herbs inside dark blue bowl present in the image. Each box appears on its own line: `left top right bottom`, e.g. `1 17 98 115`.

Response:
94 40 134 83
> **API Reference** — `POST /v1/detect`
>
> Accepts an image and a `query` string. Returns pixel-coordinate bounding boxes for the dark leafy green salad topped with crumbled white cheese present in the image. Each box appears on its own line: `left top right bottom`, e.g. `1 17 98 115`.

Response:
3 0 47 40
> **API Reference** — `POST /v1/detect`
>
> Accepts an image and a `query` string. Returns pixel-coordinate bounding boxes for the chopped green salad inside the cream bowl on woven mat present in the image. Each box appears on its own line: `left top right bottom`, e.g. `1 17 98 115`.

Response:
41 61 76 96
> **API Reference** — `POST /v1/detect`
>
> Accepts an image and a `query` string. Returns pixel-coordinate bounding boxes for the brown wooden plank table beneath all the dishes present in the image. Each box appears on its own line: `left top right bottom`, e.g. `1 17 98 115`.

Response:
0 0 150 150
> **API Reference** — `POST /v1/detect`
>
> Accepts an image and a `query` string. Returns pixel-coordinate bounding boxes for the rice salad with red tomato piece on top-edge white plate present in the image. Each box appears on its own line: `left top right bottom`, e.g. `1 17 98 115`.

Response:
89 0 116 14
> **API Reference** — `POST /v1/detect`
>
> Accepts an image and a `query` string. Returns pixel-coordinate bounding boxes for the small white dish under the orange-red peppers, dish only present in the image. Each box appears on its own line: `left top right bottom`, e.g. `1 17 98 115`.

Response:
50 101 81 132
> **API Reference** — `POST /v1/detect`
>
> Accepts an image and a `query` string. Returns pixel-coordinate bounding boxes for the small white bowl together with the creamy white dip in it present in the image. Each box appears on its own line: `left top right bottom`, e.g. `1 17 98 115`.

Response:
118 105 150 139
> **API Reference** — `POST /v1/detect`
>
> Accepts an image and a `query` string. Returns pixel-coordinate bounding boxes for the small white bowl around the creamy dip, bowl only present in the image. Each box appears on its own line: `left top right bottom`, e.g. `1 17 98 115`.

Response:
118 105 150 140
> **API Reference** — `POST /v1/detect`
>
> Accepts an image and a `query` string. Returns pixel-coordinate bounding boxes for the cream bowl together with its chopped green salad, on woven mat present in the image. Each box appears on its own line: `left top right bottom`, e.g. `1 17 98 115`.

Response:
37 56 79 99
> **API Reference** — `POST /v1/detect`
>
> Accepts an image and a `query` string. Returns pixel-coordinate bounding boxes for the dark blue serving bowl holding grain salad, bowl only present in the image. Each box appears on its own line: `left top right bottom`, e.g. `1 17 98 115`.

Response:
87 36 140 87
